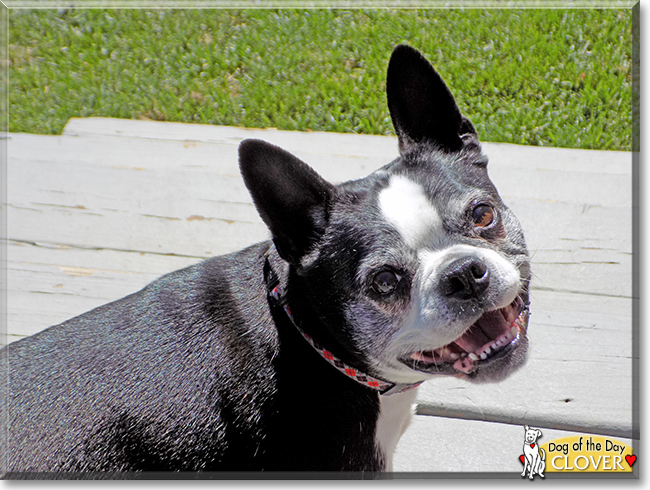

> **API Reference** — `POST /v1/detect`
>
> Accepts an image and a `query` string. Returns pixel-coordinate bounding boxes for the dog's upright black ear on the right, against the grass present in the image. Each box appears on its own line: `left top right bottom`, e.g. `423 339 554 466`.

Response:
386 44 476 153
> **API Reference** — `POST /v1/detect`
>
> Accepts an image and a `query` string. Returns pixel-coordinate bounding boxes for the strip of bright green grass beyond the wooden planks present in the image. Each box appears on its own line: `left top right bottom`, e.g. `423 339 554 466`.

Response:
9 9 632 150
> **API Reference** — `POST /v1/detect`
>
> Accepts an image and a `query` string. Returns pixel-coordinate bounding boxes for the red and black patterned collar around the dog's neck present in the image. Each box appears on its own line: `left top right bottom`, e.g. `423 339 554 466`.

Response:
267 276 422 395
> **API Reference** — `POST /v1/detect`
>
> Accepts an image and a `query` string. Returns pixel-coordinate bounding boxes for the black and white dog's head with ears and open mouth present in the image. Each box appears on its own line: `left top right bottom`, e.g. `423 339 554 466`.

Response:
240 45 530 383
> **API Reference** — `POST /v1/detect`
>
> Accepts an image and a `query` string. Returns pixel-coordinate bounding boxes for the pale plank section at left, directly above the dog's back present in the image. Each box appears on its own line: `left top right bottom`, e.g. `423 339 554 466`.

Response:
7 241 201 341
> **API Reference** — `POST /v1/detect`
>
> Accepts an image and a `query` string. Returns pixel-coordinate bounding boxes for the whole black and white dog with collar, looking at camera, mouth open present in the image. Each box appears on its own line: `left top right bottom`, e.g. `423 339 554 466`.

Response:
1 45 530 478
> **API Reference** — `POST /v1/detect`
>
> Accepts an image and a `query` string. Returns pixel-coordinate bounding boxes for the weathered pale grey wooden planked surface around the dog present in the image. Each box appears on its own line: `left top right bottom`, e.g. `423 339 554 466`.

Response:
6 118 639 472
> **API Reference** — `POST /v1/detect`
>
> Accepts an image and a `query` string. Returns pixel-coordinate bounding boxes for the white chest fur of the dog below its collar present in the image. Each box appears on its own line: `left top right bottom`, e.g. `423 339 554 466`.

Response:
375 388 418 471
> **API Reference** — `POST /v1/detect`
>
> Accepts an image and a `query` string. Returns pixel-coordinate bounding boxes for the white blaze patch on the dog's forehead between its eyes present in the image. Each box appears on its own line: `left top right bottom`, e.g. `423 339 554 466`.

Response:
379 175 443 248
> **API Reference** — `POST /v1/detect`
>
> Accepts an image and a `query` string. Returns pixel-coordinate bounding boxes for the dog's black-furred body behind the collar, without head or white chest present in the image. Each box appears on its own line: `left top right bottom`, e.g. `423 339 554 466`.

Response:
9 247 379 471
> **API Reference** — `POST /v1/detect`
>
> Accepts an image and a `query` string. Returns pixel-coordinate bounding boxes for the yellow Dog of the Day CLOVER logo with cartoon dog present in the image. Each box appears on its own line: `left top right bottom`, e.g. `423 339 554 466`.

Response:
519 426 637 474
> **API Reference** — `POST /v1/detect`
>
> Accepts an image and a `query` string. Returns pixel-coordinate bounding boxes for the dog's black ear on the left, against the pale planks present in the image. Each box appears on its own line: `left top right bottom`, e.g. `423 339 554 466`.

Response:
239 139 334 265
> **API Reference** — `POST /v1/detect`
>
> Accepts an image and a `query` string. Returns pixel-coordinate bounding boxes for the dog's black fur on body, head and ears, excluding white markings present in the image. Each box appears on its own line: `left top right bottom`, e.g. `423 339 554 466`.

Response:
1 45 530 478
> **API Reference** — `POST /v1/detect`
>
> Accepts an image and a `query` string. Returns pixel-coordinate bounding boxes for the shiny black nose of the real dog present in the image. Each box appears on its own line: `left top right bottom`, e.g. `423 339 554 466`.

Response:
440 257 490 300
